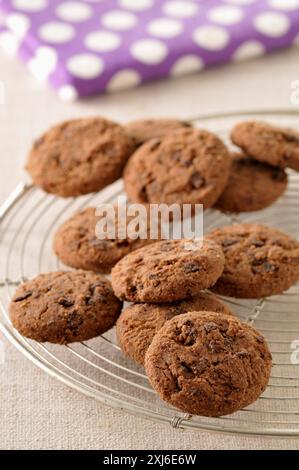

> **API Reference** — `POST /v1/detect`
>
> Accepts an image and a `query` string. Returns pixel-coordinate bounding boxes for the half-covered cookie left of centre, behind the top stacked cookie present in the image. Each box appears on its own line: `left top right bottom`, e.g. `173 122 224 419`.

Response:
54 207 161 273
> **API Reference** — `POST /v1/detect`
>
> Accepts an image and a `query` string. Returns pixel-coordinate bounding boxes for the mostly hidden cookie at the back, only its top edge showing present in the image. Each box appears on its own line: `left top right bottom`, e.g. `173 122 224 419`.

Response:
125 119 192 146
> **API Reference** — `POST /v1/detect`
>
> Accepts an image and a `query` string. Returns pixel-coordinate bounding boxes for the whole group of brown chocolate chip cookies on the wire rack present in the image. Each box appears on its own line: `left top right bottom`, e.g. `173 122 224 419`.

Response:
10 114 299 416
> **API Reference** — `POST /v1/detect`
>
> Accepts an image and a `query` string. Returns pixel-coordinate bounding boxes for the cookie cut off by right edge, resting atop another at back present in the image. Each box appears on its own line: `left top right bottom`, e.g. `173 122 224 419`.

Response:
231 121 299 171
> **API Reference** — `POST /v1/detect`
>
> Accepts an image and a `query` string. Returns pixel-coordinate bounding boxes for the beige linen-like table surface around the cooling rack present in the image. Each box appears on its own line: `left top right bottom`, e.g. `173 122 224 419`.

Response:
0 49 299 450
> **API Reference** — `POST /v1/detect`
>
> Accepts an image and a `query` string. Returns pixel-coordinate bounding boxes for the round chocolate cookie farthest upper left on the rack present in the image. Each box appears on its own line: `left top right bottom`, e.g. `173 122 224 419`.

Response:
26 118 134 197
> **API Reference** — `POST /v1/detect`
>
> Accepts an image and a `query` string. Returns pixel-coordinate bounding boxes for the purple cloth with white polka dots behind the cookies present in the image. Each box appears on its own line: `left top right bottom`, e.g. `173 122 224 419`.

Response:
0 0 299 100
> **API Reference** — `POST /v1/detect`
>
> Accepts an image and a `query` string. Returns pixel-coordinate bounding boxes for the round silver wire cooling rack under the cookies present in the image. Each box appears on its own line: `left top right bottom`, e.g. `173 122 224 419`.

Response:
0 111 299 436
